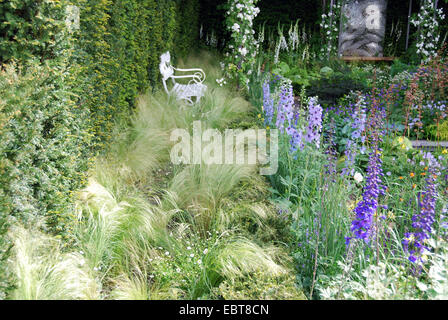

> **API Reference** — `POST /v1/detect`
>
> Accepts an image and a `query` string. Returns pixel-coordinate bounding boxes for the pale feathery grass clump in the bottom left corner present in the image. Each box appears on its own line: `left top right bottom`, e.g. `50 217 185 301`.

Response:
10 226 100 300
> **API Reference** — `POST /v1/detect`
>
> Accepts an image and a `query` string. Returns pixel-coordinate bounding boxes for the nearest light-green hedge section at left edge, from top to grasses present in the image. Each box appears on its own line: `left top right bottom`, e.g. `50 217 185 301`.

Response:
0 0 90 235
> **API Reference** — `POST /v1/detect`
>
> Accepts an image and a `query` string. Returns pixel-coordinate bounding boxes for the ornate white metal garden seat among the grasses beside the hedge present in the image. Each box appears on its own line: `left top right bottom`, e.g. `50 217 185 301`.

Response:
159 51 207 105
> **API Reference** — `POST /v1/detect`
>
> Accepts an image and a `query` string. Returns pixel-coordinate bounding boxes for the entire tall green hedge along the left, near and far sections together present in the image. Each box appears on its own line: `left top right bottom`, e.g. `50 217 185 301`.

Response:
0 0 199 299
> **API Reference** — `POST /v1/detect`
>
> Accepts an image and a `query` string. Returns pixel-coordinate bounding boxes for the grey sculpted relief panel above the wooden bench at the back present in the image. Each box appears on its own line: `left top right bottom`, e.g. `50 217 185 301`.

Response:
339 0 387 57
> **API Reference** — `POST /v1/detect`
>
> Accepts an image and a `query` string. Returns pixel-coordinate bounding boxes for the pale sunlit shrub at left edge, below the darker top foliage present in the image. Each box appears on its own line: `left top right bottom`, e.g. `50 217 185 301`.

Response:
0 62 88 233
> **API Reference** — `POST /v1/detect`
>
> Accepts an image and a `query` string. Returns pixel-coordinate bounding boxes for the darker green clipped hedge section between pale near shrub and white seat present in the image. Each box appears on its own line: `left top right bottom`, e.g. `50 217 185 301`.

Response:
71 0 199 140
